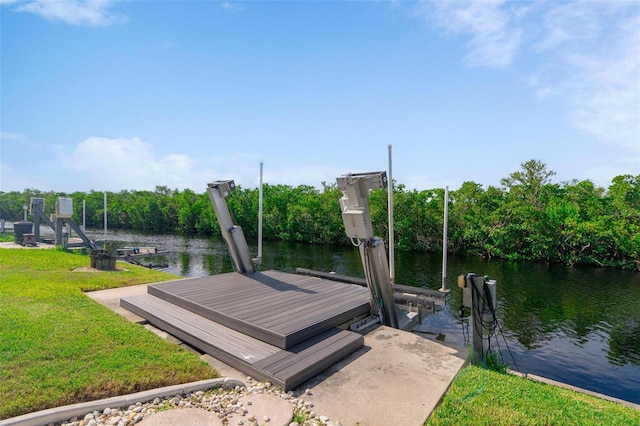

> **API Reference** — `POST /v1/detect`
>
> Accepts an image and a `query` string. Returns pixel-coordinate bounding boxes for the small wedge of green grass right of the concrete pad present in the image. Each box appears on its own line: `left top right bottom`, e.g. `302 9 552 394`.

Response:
425 366 640 426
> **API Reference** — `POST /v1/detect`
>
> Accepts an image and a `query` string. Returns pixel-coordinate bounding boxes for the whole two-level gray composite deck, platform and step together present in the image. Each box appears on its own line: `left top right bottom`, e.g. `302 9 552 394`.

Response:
120 271 370 390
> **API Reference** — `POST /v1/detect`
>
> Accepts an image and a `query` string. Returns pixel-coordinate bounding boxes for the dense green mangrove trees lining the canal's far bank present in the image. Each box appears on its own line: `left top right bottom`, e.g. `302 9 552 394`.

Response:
0 160 640 270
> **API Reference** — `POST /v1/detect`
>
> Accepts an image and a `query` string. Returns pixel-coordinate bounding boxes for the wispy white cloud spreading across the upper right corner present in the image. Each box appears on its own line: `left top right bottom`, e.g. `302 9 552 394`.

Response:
418 0 640 155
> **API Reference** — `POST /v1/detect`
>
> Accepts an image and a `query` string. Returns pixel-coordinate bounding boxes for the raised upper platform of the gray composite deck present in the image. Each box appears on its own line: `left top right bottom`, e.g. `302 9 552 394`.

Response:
143 271 370 349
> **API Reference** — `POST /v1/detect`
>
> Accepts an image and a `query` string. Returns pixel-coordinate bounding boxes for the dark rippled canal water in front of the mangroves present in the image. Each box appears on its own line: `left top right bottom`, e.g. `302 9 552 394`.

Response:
91 231 640 404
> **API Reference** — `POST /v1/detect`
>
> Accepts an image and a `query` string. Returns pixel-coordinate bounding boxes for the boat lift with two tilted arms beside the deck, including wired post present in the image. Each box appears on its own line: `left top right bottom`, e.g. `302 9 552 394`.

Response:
207 171 495 353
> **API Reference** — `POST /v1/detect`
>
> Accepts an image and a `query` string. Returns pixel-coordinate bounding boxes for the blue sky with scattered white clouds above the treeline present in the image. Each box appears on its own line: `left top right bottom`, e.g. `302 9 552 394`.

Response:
0 0 640 192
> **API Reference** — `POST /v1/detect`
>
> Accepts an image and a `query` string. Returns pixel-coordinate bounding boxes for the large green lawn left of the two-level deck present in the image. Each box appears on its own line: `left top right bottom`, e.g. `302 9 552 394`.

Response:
0 249 217 419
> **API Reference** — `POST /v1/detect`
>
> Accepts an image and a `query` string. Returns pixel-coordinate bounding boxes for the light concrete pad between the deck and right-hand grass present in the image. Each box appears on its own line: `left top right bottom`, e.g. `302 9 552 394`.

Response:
295 326 466 426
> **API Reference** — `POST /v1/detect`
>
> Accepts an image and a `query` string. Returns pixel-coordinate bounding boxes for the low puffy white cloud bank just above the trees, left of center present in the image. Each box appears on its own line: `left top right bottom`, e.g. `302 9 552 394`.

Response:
48 137 344 192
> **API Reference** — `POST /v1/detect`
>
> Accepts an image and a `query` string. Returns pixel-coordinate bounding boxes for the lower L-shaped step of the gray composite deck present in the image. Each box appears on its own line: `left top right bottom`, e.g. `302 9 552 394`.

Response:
120 294 364 391
